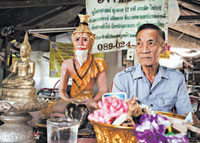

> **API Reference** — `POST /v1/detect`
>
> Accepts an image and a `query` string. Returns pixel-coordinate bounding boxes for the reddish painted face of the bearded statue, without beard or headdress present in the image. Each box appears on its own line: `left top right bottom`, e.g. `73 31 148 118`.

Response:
73 32 91 50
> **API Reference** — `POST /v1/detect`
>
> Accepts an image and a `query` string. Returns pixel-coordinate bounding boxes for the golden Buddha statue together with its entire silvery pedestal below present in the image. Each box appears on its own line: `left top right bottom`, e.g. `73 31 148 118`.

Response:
0 33 47 143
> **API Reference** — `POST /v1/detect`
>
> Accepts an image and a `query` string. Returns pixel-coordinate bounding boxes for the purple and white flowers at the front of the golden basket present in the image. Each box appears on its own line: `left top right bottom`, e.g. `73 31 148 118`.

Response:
134 114 189 143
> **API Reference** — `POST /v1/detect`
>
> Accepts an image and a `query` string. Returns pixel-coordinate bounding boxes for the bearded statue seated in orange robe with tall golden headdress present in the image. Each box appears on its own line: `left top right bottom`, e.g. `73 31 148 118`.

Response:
51 15 107 117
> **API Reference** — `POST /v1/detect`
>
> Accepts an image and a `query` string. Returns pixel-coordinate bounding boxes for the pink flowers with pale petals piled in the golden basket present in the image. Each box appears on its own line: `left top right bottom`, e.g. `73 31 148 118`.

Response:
88 97 128 124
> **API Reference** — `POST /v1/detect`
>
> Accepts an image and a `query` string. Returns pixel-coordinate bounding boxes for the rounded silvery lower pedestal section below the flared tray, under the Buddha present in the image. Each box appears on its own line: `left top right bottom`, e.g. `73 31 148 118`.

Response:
0 112 35 143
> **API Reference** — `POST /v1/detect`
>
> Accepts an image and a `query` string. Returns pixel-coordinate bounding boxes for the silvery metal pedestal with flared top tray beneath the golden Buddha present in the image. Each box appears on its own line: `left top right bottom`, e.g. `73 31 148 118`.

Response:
0 100 47 143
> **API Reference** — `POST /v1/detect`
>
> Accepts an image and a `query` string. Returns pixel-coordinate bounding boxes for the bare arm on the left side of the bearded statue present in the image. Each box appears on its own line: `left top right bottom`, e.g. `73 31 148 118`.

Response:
59 61 74 102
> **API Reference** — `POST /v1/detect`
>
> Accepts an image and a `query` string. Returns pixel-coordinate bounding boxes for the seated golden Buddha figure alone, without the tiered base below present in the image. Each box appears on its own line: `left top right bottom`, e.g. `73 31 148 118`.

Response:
3 33 35 88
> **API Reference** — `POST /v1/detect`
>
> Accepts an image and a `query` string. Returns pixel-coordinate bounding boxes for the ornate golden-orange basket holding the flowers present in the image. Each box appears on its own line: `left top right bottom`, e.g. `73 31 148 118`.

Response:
91 121 137 143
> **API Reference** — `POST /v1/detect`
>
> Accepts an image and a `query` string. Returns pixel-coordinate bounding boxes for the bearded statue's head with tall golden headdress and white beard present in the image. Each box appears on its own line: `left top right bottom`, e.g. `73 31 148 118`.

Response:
72 14 95 66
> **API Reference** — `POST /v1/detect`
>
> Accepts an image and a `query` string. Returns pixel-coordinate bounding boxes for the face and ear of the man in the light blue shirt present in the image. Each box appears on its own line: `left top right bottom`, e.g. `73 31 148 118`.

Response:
136 29 166 67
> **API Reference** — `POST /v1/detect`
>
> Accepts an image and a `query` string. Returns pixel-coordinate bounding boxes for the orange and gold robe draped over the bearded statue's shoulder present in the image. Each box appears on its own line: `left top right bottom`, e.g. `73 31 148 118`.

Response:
70 56 107 99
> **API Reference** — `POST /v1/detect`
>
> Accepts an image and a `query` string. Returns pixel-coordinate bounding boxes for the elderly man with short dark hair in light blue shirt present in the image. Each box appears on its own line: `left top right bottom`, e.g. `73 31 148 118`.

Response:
112 24 192 114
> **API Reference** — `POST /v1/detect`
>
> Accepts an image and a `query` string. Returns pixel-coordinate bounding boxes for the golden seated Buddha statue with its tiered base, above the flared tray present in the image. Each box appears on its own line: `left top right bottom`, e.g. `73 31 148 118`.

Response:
0 33 37 101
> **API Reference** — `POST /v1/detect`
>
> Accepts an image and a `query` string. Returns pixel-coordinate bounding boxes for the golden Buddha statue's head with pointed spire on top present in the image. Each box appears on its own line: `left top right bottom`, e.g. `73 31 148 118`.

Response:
20 32 31 58
